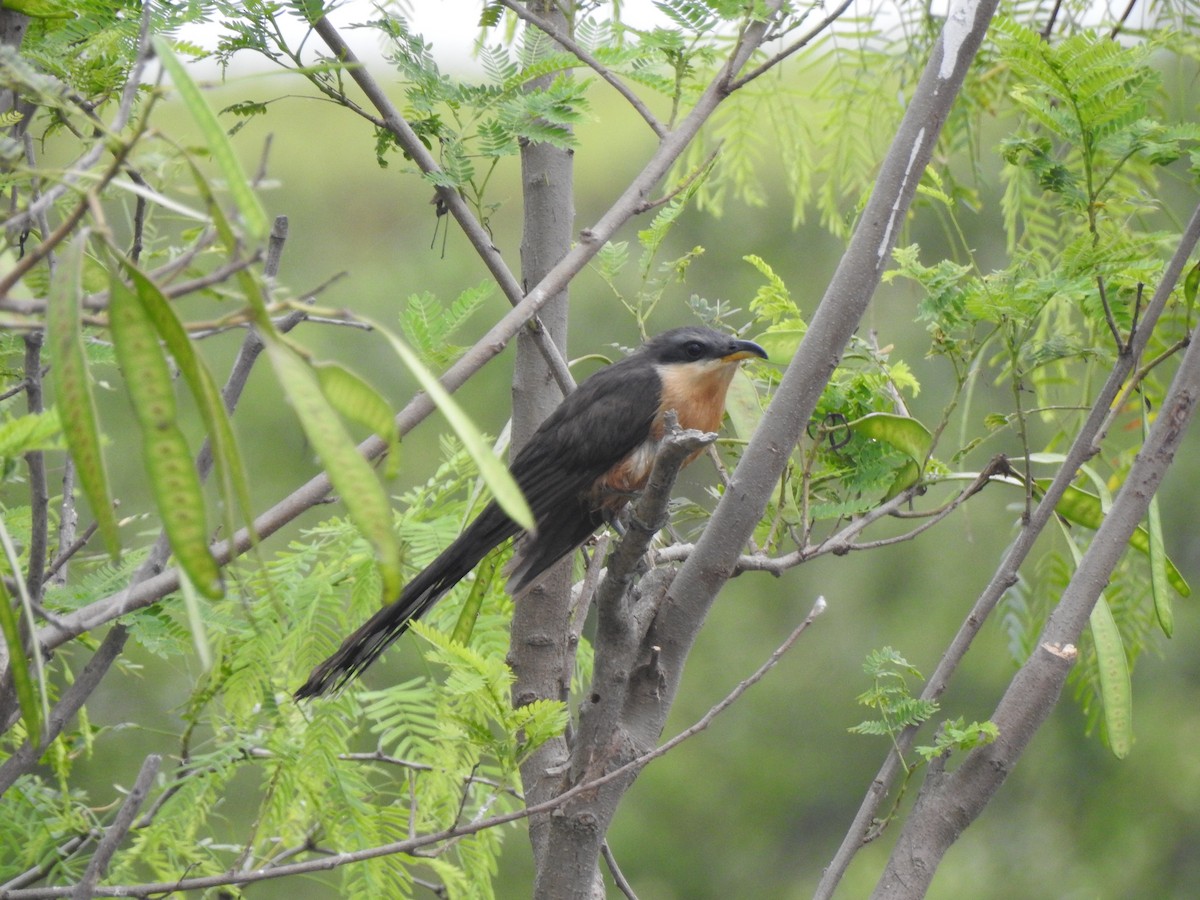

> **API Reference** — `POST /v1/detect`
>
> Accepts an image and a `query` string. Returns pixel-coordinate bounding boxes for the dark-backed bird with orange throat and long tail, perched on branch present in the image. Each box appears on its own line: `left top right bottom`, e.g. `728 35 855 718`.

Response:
295 325 767 700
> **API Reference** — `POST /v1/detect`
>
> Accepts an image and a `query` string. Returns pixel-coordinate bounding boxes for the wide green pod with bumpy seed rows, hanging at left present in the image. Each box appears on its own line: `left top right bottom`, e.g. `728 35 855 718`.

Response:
108 269 224 599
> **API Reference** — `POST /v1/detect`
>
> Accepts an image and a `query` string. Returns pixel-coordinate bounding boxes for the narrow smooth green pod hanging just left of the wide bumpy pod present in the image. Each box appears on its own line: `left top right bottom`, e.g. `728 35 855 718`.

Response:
47 232 121 559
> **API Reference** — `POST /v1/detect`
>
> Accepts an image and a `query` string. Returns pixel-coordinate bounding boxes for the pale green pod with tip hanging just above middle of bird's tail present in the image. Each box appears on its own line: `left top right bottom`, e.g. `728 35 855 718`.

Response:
260 331 404 596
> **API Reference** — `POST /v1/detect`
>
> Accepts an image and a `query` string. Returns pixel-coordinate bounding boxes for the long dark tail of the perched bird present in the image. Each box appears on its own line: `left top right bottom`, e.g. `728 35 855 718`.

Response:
295 503 521 700
